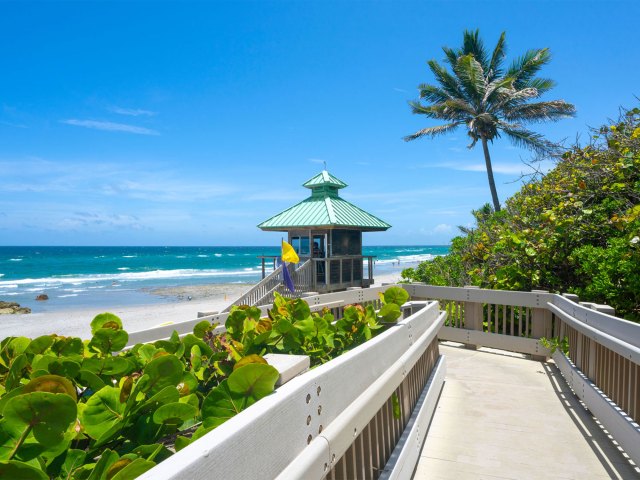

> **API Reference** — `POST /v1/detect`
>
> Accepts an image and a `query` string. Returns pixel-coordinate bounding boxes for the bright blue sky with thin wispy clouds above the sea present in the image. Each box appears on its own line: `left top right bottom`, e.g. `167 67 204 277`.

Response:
0 1 640 245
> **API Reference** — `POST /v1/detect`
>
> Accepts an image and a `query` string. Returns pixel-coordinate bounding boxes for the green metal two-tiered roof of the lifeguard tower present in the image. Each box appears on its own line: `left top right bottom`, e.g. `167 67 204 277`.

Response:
258 170 391 231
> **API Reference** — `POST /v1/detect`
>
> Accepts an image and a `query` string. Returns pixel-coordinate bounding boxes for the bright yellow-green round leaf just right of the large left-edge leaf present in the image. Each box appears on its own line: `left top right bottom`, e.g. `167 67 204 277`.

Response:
80 385 125 439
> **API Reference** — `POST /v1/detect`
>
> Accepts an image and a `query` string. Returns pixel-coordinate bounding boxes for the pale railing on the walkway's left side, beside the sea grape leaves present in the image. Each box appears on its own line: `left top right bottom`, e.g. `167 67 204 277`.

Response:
130 287 446 480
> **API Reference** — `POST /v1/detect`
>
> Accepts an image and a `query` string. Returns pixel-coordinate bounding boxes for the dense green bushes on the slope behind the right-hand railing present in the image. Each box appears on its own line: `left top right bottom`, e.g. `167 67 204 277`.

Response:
403 108 640 321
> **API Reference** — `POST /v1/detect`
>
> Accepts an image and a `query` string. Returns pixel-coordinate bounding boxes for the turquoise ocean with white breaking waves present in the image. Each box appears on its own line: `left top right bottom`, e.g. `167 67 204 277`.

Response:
0 246 449 313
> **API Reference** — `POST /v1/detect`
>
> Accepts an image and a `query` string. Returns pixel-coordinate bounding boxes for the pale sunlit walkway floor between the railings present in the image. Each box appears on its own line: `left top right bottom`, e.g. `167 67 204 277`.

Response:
414 342 640 480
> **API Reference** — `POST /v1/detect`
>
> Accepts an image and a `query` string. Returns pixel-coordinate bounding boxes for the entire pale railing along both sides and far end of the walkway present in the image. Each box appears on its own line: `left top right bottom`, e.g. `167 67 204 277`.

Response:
130 284 640 479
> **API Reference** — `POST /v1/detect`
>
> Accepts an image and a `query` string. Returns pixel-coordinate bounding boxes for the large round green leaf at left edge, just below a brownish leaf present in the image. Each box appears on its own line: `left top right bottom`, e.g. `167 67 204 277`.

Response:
2 392 78 447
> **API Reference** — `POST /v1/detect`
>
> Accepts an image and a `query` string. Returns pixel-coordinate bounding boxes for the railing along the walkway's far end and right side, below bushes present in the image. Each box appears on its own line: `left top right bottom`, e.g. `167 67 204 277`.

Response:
403 284 640 464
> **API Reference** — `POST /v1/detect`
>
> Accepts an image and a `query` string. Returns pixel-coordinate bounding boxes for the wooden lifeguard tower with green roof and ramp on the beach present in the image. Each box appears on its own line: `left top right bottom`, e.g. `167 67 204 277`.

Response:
222 170 391 305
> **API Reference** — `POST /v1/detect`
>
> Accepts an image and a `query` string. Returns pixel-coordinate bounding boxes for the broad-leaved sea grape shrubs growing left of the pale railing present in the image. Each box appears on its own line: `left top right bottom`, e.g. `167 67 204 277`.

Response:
0 287 408 480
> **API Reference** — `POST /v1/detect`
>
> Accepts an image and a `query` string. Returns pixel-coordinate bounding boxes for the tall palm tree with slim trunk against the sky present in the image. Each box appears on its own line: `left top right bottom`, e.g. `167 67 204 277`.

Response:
404 30 575 211
